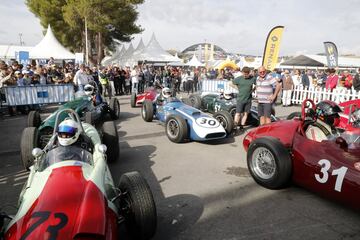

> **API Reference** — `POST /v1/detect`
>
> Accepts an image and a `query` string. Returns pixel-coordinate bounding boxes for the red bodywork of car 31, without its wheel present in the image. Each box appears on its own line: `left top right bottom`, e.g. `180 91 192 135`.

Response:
243 118 360 209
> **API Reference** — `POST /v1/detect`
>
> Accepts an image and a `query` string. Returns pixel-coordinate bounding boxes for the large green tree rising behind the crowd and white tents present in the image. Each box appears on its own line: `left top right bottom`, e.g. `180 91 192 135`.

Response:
26 0 144 63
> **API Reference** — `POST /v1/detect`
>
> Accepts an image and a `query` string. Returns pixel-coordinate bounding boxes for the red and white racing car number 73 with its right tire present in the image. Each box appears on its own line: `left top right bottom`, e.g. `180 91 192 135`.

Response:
0 109 157 240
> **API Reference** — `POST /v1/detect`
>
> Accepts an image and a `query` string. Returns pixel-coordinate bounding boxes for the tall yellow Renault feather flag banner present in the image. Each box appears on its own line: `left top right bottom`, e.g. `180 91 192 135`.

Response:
262 26 284 70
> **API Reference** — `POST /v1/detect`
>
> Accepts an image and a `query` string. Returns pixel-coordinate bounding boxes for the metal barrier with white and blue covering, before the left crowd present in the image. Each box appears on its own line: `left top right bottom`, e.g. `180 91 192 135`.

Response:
4 84 74 106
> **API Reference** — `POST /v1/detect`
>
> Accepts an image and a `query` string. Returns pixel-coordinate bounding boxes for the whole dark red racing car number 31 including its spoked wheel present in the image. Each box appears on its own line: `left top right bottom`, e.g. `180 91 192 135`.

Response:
243 100 360 209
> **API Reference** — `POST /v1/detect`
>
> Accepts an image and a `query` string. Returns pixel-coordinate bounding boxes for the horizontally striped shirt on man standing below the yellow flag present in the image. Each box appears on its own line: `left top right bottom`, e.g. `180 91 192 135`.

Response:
256 74 277 103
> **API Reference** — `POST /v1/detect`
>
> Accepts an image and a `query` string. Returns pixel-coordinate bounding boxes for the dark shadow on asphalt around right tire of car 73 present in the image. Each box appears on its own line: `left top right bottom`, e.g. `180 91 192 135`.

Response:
115 138 204 239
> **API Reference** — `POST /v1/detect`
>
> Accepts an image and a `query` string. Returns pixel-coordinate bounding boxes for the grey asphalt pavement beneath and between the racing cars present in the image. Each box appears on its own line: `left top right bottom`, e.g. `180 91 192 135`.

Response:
0 96 360 240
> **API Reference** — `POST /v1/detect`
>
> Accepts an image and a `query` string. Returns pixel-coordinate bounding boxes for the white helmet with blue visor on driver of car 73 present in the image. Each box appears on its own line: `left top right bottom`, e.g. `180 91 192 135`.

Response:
57 119 80 146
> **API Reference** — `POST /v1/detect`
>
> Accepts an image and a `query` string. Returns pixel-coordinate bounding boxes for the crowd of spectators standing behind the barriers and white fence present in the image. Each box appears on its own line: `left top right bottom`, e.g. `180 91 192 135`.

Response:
0 59 360 105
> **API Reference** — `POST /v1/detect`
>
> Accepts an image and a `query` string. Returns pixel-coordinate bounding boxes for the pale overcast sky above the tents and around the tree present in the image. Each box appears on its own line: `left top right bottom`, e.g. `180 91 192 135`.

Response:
0 0 360 56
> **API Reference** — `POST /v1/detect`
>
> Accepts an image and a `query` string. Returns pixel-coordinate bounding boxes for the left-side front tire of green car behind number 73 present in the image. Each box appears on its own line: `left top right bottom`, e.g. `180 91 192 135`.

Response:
20 127 39 171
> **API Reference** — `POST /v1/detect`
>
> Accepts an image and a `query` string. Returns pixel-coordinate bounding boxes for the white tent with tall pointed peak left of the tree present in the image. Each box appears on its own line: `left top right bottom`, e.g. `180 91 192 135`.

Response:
29 25 75 59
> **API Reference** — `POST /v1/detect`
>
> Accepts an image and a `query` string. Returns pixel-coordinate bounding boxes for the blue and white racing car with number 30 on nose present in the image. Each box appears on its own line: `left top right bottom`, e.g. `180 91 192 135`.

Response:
141 97 234 143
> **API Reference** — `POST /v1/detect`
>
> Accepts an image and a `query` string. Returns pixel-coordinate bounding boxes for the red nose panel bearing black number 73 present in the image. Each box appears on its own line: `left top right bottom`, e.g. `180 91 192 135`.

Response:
5 166 117 239
